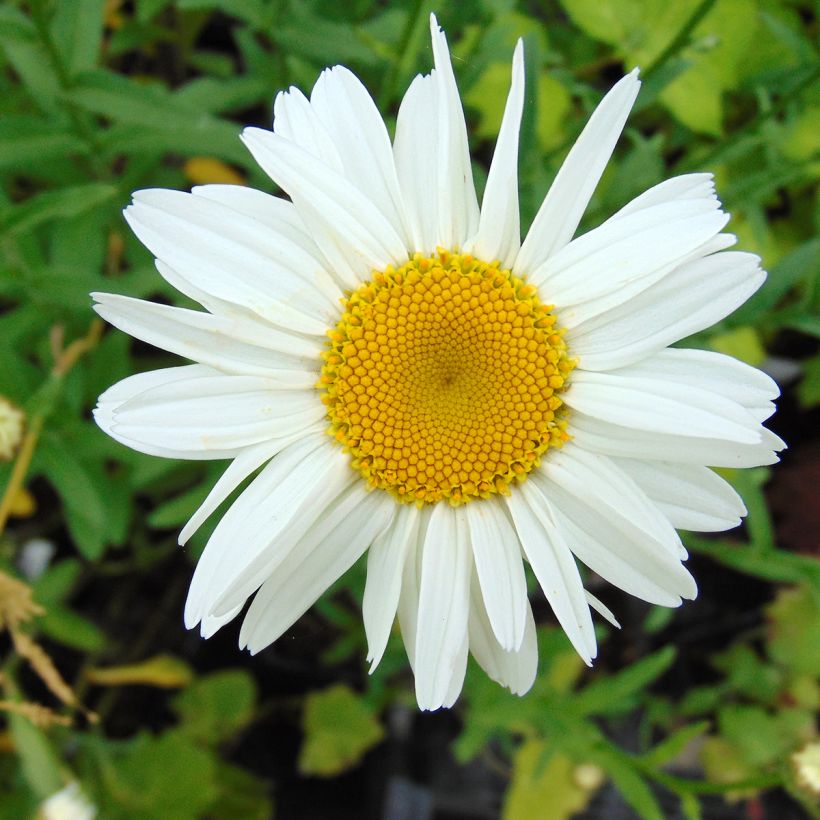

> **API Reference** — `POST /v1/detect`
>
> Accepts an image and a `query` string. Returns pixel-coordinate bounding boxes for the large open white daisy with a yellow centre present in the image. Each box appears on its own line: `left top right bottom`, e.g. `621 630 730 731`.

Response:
95 17 784 709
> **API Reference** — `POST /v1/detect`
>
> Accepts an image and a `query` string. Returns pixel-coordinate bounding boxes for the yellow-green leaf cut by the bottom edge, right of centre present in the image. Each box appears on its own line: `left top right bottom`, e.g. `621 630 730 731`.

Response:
502 740 592 820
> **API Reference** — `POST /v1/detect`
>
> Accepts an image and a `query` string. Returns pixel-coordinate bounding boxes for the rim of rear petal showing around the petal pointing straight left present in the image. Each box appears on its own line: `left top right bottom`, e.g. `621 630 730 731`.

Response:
94 364 241 460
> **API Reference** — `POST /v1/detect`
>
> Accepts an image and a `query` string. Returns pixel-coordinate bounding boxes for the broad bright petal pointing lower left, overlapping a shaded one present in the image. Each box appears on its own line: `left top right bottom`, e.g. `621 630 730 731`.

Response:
185 433 354 629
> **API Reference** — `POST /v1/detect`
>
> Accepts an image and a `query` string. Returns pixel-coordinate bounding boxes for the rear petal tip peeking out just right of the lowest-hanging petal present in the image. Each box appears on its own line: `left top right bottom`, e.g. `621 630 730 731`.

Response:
469 575 538 695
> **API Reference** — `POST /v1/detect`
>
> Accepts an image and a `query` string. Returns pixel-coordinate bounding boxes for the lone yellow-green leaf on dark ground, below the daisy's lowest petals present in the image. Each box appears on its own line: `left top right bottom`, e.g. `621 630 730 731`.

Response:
299 684 384 777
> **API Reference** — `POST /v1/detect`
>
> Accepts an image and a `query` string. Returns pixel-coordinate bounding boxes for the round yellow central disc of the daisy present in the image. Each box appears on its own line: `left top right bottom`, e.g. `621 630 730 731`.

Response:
318 250 573 504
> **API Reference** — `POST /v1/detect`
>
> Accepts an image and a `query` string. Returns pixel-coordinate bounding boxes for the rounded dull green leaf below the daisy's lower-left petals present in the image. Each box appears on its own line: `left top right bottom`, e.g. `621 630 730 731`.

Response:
173 669 256 744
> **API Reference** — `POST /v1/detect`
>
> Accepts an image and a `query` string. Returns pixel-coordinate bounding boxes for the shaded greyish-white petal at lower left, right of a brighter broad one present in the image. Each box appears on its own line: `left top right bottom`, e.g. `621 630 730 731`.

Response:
239 482 396 654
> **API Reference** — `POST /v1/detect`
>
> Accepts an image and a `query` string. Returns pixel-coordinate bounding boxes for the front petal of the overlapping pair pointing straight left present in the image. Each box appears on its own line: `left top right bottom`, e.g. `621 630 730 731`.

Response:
113 373 326 451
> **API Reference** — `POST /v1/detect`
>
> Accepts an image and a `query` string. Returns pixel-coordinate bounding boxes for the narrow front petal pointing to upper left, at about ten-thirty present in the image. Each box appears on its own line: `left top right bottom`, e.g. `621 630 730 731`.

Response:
242 128 408 288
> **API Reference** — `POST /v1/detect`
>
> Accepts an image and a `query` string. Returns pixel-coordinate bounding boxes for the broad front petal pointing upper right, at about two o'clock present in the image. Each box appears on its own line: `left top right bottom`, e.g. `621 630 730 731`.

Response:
529 200 729 310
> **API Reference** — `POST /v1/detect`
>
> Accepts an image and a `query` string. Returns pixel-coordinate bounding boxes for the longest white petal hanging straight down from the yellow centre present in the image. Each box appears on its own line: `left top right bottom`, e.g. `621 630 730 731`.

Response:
413 504 472 710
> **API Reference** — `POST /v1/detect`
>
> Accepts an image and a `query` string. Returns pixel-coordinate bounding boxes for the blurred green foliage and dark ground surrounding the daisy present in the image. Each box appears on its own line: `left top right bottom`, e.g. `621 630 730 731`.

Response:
0 0 820 820
